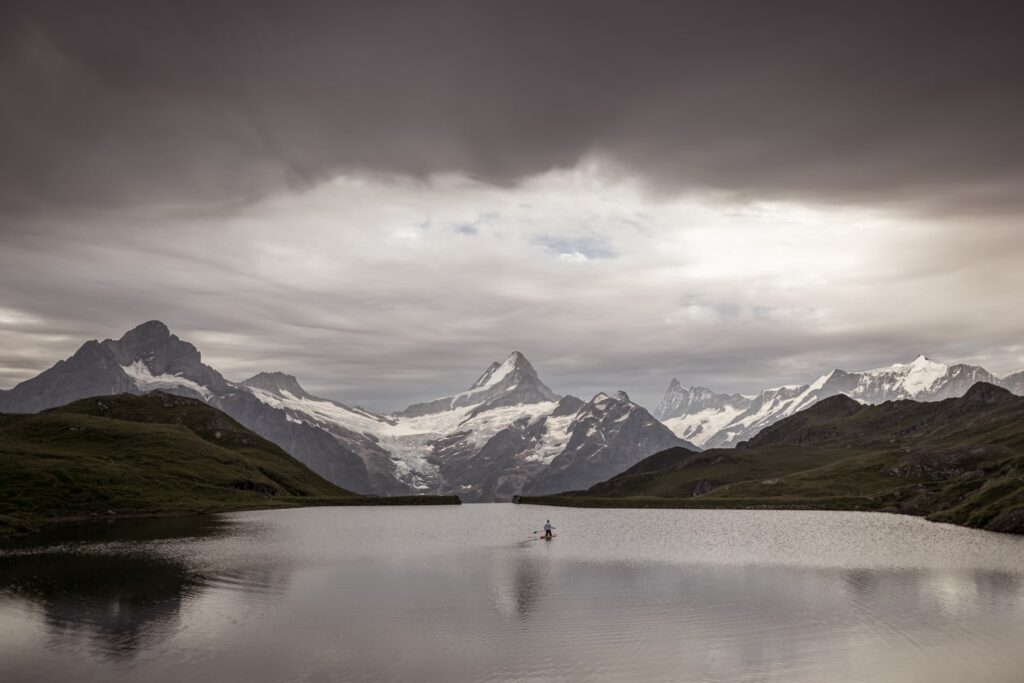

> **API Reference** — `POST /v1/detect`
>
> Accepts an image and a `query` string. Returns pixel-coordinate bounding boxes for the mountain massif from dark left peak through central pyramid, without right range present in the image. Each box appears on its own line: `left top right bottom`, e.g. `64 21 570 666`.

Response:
0 321 696 501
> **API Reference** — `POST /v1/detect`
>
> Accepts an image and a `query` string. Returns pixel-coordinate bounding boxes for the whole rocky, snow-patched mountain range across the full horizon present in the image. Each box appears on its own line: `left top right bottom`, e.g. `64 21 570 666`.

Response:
0 321 1024 502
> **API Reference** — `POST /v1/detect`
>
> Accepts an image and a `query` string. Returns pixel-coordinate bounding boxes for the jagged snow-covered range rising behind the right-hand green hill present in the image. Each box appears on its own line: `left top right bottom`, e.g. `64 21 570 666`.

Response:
654 355 1024 449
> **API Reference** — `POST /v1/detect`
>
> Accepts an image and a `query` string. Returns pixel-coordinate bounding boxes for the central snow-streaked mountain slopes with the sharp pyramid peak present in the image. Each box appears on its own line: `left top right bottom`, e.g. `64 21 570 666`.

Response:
235 352 692 500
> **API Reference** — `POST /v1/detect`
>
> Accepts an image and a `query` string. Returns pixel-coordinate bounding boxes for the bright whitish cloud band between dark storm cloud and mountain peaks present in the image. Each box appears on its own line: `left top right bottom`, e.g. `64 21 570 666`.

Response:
0 164 1024 411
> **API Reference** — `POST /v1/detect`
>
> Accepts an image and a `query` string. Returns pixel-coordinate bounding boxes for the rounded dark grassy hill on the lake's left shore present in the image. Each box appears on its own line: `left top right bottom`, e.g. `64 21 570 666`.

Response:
0 392 457 533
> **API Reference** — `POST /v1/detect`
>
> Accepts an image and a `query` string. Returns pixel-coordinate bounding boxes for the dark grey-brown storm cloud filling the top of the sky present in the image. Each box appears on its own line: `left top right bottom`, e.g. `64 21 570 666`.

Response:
6 0 1024 212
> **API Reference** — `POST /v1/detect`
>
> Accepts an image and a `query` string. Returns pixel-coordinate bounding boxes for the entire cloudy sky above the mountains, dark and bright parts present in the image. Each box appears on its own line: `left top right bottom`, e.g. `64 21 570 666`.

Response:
0 0 1024 411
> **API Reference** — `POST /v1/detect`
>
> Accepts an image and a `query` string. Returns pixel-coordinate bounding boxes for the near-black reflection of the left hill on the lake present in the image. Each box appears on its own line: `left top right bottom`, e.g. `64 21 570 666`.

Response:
0 517 230 658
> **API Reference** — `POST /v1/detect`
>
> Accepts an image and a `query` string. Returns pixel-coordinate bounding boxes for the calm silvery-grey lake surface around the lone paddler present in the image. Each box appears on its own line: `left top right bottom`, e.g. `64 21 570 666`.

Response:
0 505 1024 683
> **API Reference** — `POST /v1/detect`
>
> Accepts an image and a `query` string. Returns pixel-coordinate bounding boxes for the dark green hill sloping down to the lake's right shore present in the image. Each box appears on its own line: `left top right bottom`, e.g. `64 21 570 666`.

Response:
520 383 1024 533
